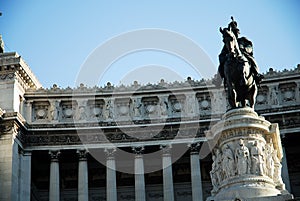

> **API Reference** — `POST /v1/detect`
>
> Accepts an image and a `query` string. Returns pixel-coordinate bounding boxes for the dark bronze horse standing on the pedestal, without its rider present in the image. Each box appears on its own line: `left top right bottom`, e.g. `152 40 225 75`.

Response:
220 27 257 109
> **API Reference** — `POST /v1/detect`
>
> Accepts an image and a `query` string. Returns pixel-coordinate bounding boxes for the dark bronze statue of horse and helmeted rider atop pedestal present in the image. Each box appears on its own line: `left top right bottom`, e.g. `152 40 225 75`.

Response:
218 17 263 109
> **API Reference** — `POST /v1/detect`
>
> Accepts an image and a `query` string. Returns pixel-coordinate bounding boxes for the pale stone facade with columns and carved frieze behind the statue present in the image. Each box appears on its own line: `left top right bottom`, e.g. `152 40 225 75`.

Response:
0 53 300 201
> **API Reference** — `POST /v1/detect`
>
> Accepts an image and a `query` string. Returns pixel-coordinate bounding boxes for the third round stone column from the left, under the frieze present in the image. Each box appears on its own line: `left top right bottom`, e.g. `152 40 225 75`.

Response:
104 148 117 201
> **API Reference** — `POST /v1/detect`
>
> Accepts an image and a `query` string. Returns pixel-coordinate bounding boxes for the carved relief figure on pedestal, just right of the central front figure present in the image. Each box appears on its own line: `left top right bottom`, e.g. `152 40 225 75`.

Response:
250 141 265 175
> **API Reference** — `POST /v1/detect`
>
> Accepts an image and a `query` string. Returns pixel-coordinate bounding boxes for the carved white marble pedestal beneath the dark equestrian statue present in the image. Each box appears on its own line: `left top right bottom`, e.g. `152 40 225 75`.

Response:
206 108 293 201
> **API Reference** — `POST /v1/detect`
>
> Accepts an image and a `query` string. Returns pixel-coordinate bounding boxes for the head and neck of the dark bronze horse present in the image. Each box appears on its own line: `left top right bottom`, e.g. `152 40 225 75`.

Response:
220 27 241 57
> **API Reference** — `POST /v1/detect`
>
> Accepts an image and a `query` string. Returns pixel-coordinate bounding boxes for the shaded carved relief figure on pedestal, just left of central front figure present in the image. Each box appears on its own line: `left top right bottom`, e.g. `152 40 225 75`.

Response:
222 144 235 178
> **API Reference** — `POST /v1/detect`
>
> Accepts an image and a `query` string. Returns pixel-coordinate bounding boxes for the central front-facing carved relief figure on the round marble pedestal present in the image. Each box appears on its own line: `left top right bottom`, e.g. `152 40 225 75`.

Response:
235 139 250 175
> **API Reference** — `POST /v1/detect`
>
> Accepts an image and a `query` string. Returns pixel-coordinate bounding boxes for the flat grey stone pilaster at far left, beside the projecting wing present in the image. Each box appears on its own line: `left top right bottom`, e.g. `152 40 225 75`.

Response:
20 150 31 201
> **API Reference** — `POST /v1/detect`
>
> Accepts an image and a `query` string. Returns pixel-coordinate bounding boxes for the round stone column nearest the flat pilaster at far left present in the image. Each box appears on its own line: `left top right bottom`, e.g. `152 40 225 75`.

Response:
49 151 60 201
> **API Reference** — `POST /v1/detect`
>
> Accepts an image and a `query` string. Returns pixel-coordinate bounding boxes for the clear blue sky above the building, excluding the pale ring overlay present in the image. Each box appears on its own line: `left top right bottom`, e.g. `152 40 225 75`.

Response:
0 0 300 88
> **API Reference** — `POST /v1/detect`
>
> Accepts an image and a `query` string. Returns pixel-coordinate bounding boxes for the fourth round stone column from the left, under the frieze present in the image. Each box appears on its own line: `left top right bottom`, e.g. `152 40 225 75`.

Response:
132 147 146 201
